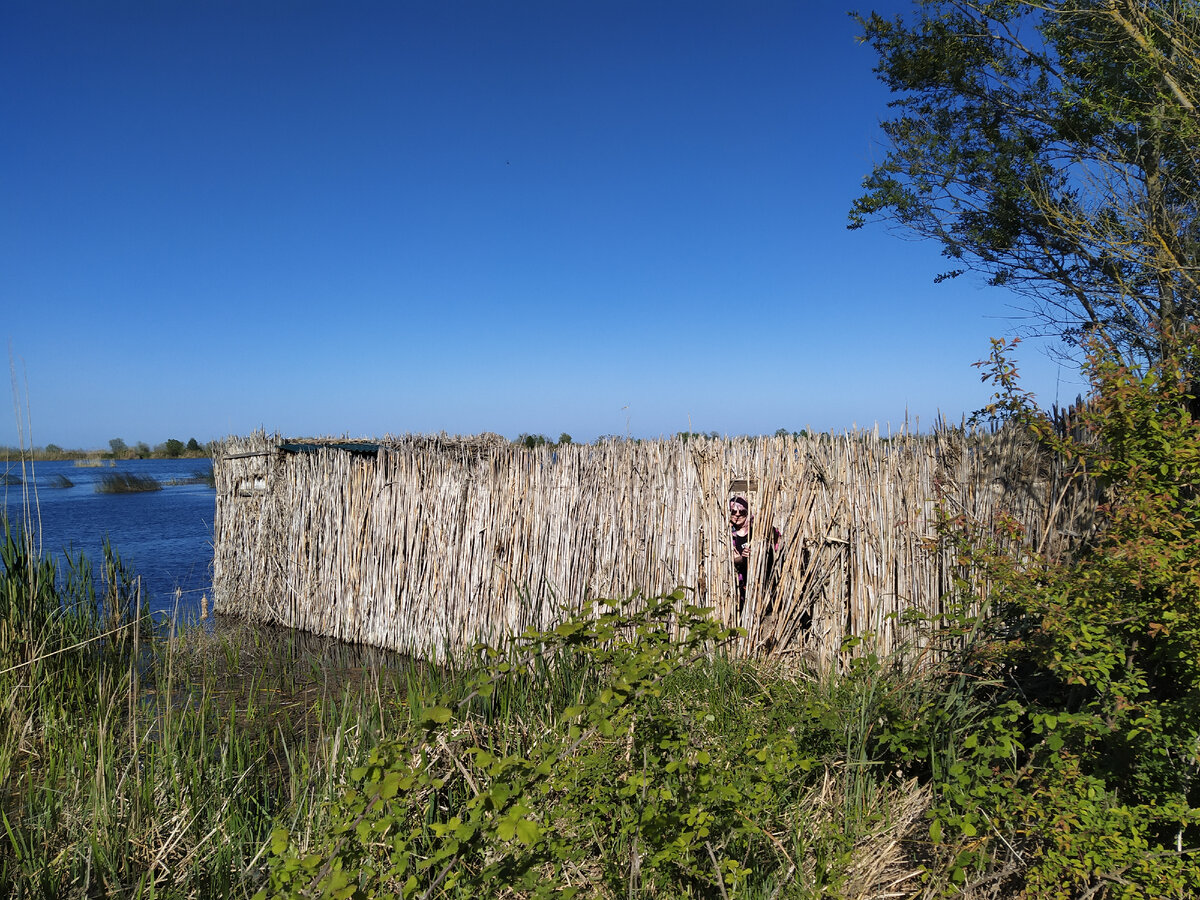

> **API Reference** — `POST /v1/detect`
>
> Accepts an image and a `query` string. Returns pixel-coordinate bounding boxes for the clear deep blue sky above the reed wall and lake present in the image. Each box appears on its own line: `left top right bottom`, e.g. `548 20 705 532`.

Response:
0 0 1081 448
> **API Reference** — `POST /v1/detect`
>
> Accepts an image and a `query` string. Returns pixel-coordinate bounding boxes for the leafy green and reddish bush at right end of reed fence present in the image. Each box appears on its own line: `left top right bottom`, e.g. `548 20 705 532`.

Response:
878 346 1200 898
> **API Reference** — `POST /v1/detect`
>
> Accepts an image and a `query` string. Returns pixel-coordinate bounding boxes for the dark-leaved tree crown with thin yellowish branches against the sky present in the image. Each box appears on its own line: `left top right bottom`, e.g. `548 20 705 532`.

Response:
850 0 1200 362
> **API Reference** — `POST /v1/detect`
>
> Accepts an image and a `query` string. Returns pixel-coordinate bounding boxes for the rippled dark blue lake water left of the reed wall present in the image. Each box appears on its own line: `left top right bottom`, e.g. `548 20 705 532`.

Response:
0 458 216 622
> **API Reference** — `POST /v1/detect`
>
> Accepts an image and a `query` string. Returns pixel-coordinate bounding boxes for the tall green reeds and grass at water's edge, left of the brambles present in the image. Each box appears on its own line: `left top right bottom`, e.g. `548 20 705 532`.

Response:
0 518 420 898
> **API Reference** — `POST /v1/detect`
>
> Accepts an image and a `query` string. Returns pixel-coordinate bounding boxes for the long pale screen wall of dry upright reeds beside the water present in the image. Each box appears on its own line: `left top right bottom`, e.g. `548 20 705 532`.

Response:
214 426 1094 664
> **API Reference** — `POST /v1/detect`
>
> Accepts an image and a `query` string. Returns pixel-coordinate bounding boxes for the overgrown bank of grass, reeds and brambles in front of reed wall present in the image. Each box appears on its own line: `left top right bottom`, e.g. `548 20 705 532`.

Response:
0 520 950 898
